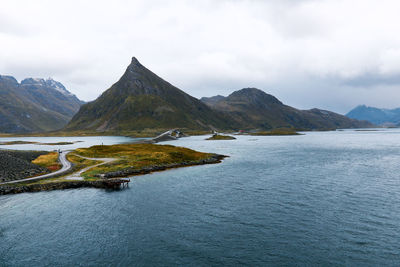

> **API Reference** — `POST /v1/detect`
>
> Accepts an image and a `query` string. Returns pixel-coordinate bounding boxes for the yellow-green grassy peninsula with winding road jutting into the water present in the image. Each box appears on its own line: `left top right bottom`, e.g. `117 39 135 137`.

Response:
0 144 226 195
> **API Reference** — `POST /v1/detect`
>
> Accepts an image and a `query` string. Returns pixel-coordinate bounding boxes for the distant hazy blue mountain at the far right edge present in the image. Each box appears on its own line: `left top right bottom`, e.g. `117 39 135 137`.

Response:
346 105 400 125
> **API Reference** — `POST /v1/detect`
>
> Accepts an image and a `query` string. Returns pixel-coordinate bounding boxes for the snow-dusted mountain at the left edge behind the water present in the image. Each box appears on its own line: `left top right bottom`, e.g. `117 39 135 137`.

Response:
0 75 83 133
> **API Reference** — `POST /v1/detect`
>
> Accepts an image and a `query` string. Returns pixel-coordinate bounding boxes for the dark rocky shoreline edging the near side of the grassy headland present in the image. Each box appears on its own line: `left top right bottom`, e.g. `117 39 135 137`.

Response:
0 154 228 195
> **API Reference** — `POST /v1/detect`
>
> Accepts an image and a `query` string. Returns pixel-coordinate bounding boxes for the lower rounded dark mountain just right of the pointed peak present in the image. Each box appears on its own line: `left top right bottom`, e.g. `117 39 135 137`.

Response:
202 88 372 130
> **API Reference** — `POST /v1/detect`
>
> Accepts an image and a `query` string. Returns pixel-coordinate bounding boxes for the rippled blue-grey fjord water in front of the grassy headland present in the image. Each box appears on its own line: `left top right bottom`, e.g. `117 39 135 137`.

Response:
0 131 400 266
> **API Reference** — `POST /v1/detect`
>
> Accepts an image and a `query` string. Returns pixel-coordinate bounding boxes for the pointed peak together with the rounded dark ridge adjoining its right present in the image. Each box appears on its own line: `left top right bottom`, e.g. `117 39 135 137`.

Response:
64 58 372 132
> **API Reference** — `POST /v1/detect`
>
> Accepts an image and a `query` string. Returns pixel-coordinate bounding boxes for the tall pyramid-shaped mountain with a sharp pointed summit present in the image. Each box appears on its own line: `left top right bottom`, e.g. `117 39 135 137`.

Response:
65 57 231 131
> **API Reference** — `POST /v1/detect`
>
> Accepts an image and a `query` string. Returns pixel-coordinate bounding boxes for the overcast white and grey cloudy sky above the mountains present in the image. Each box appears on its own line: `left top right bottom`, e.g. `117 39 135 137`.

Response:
0 0 400 114
